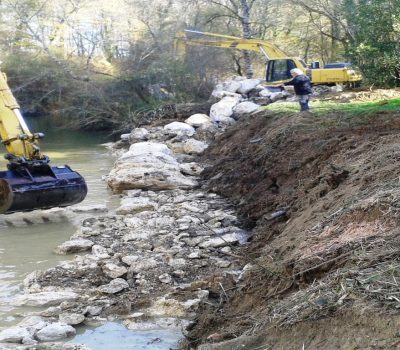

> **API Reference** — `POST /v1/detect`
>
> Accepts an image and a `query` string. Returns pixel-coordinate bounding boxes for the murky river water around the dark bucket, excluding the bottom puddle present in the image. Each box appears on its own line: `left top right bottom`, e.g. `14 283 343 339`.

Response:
0 121 117 326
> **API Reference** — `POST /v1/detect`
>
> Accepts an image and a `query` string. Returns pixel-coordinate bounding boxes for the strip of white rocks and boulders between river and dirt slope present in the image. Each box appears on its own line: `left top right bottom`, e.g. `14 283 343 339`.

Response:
0 79 278 350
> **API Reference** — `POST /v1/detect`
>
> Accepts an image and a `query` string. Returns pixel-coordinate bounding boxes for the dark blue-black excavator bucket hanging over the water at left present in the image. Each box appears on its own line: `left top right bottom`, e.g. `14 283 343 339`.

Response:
0 165 87 214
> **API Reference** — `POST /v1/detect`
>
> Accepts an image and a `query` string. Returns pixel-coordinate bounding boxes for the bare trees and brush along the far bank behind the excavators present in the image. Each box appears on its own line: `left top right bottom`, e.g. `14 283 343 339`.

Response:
0 0 400 130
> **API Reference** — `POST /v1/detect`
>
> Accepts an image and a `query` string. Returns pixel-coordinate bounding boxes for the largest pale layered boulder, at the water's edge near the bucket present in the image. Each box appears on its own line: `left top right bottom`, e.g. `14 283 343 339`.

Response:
107 142 197 193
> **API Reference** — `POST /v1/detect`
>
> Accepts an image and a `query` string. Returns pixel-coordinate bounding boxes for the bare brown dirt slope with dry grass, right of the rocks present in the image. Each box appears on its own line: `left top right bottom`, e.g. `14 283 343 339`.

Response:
187 111 400 350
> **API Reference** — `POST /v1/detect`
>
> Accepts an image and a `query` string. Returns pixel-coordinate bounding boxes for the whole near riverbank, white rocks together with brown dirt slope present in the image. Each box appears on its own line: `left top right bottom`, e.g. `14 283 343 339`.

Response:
0 80 399 350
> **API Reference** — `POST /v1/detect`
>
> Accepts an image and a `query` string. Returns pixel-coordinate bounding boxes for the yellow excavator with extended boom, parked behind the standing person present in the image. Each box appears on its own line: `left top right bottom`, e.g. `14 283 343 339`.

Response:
175 30 362 86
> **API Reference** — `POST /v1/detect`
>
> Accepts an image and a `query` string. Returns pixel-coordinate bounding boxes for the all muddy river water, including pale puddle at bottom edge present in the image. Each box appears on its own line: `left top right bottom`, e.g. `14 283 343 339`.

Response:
0 120 181 350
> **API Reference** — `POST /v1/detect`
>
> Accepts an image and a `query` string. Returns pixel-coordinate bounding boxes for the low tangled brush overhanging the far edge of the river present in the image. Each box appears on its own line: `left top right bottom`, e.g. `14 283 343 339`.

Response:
3 52 211 131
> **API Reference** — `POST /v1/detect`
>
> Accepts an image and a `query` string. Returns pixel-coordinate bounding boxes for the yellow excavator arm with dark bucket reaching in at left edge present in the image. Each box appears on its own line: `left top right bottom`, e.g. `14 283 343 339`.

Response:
0 72 87 214
